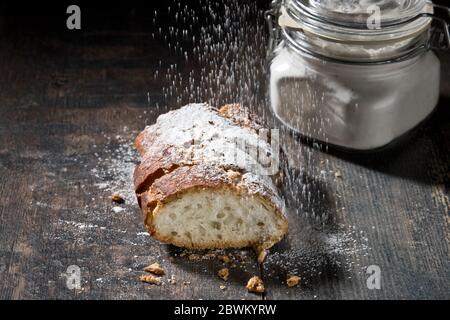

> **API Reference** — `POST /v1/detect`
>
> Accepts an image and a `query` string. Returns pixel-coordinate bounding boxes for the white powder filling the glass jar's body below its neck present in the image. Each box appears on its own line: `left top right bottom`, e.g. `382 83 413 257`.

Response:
270 42 440 150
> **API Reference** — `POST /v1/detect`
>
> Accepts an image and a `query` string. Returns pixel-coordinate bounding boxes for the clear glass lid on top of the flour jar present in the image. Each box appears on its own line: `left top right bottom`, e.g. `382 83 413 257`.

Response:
279 0 433 42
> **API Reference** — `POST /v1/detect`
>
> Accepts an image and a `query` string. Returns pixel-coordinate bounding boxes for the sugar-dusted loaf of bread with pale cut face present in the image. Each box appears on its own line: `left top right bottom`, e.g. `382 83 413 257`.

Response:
134 104 288 250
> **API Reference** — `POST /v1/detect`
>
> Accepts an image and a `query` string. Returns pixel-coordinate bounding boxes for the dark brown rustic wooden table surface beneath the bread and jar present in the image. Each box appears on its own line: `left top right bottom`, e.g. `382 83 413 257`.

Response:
0 1 450 299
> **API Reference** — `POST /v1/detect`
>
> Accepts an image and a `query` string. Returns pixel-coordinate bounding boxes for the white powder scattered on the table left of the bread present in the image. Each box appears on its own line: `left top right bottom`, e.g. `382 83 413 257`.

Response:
46 127 149 247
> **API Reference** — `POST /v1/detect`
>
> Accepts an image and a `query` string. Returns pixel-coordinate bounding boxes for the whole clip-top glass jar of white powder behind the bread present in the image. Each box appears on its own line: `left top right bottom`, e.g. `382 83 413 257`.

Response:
267 0 450 150
